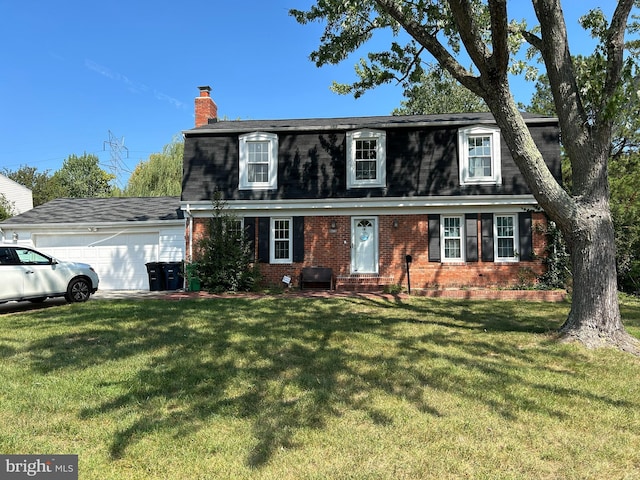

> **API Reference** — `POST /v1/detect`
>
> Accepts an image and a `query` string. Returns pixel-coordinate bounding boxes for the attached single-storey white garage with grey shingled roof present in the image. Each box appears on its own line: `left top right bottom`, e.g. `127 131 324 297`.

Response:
0 197 185 290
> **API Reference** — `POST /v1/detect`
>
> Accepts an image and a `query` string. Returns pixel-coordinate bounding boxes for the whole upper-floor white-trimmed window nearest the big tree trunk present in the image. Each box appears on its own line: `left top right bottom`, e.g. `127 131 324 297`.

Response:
458 126 502 185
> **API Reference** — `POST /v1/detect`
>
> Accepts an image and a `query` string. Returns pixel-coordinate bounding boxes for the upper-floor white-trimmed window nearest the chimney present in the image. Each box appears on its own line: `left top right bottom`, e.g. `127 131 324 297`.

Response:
239 132 278 190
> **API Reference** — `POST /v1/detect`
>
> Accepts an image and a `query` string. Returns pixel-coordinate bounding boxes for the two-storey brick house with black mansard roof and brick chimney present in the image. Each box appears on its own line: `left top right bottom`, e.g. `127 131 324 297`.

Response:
181 87 561 289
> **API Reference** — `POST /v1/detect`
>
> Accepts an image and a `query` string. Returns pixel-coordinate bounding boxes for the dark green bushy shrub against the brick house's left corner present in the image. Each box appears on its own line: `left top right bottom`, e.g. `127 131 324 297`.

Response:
194 194 260 293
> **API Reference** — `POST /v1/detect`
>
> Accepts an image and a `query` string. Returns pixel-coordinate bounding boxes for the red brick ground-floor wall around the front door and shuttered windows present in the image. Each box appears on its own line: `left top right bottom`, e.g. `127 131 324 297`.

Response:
187 213 546 290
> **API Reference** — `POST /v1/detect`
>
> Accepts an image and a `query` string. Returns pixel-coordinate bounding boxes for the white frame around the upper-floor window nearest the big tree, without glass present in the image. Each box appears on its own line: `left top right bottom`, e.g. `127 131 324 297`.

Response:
458 126 502 186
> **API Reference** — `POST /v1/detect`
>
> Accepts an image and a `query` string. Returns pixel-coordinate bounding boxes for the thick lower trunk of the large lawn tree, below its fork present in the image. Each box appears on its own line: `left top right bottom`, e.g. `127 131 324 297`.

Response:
560 200 638 353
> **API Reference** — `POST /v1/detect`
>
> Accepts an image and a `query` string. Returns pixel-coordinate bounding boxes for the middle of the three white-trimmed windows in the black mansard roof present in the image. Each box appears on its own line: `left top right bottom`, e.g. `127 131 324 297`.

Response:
347 130 387 188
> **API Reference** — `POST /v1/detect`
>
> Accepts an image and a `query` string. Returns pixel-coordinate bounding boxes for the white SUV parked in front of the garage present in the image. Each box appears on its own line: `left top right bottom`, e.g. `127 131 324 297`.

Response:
0 248 98 303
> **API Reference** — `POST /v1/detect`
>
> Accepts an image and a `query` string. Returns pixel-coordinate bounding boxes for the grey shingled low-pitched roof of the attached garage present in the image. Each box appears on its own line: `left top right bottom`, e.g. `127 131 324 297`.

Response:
0 197 184 225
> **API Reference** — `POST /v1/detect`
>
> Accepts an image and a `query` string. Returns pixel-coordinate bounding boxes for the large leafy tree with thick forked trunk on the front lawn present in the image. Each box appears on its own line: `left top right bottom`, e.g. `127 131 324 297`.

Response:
291 0 640 353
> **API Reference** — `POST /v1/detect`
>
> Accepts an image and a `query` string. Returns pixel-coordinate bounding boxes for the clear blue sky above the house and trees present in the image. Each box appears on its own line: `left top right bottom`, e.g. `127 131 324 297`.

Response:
0 0 613 188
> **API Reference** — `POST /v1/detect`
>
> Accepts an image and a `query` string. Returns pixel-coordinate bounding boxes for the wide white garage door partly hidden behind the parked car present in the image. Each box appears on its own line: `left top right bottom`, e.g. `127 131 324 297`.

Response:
34 233 159 290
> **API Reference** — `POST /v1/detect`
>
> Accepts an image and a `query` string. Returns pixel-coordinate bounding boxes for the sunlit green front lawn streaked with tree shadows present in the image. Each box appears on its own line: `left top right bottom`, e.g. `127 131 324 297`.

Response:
0 296 640 480
